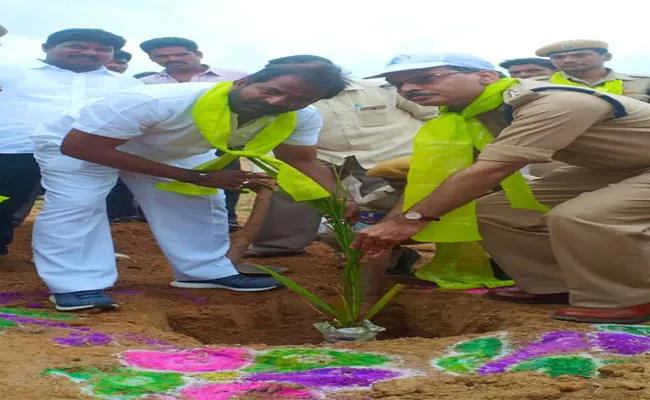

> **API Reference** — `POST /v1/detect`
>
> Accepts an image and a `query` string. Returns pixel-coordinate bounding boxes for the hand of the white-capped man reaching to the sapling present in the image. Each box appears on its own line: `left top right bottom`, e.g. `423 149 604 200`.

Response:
350 215 431 258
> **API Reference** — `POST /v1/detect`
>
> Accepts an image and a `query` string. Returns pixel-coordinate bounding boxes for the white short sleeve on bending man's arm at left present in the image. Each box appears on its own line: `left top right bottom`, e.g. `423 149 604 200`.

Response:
72 92 162 139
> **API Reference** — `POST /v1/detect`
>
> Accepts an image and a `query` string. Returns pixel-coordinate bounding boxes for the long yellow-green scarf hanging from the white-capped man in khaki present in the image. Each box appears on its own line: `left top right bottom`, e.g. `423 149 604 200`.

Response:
403 78 549 289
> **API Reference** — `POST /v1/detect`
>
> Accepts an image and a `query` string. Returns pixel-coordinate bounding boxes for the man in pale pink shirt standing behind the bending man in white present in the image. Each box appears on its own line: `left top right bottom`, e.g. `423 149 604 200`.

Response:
140 37 248 232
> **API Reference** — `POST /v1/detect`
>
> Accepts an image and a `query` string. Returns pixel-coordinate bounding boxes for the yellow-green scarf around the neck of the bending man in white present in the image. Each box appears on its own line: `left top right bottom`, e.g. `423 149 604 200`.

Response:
157 82 330 201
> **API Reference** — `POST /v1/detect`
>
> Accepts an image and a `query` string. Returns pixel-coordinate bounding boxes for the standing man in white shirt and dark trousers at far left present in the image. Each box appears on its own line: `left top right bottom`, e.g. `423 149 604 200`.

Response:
0 29 142 255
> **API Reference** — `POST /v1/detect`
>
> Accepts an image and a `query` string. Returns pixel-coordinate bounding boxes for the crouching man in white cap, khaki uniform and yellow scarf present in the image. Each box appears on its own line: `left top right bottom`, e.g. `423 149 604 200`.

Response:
353 53 650 323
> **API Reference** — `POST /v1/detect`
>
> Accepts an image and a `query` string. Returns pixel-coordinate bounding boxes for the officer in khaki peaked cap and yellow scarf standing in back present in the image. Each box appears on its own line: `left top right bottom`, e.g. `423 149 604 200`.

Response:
535 40 650 102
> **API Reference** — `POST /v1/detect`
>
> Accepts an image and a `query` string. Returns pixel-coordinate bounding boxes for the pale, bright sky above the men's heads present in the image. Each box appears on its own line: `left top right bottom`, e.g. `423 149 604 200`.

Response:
0 0 650 76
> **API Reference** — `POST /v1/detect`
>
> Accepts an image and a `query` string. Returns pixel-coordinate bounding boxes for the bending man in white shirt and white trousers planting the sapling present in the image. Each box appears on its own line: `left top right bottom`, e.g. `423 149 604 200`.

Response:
33 66 354 311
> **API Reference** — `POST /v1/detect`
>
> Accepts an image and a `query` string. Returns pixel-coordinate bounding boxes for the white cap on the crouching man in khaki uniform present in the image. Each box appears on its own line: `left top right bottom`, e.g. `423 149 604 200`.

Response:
365 52 496 79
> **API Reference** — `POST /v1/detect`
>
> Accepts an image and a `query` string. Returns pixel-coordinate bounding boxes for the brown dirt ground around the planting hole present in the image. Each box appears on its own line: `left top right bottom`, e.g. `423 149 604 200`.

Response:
0 198 650 400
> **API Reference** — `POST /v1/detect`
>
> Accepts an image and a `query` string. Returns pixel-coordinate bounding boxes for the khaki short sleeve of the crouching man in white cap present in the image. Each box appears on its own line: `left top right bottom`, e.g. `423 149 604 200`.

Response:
478 92 614 163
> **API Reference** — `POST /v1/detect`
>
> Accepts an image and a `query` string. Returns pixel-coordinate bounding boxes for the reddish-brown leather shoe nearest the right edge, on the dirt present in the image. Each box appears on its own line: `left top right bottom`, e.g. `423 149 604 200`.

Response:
551 303 650 324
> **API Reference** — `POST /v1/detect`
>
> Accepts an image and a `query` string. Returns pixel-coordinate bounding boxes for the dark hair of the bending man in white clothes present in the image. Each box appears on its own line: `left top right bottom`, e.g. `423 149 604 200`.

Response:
244 64 350 99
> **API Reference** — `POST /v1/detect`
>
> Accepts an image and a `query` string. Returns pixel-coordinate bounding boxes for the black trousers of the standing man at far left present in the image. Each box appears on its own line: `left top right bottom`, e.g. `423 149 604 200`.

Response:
0 153 41 246
